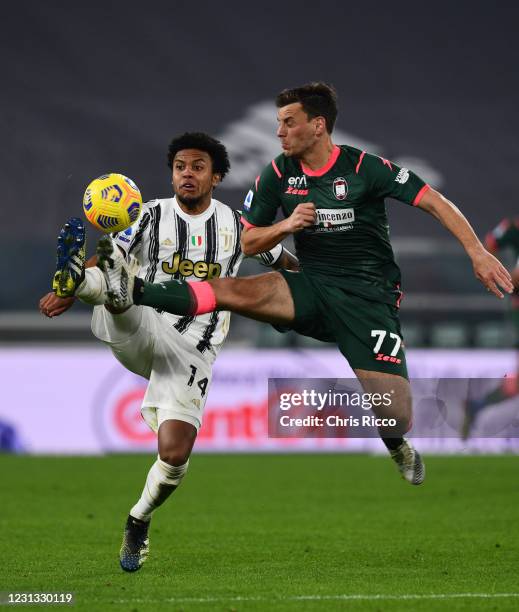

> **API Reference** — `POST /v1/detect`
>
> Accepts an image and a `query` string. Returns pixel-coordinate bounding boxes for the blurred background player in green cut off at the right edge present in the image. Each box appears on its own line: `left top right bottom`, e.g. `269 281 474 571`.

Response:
461 217 519 440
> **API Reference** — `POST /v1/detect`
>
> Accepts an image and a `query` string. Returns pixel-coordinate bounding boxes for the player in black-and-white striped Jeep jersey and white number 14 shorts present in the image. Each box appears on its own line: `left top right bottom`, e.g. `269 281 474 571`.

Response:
40 133 298 571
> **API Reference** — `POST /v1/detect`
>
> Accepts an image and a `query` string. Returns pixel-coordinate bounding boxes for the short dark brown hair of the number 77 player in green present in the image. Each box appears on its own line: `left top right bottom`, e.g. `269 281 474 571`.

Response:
276 81 338 134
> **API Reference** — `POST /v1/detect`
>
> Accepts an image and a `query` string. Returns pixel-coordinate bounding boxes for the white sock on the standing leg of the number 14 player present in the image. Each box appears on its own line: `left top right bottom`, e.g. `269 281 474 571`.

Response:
130 458 189 521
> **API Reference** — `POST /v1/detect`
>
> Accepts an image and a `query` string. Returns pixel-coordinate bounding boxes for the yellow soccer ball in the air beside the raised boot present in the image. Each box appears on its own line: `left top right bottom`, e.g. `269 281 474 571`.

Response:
83 173 142 234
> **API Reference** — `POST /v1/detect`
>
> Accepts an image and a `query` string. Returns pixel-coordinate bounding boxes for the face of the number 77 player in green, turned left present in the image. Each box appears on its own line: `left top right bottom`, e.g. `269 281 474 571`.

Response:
277 102 322 158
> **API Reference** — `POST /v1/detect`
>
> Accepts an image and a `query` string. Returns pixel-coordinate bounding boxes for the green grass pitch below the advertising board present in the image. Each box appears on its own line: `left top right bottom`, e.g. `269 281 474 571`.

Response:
0 452 519 612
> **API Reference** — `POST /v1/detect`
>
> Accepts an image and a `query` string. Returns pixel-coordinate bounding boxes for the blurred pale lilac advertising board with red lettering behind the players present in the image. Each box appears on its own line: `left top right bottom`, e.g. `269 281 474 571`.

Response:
0 346 519 454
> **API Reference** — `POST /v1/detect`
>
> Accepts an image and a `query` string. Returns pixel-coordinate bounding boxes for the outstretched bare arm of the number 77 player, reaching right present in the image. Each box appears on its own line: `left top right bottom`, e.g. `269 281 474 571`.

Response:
419 189 513 298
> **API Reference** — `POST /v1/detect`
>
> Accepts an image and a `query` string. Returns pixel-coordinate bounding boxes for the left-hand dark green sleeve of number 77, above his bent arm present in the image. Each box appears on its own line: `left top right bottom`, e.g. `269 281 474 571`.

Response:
242 160 282 227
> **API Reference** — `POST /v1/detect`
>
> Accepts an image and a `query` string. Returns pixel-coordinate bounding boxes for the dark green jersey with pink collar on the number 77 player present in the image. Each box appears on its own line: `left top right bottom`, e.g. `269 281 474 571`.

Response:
242 145 429 305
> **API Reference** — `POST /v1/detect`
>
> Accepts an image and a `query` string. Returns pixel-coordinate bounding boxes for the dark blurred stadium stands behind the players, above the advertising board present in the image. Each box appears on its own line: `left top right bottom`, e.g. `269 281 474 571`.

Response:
0 1 519 346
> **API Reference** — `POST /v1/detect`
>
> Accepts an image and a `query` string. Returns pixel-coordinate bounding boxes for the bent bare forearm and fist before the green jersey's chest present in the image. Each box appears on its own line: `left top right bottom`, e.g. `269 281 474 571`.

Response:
241 202 315 257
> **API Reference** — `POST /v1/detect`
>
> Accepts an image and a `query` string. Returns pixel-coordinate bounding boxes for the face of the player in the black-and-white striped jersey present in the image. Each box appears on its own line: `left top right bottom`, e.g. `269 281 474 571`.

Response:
171 149 220 208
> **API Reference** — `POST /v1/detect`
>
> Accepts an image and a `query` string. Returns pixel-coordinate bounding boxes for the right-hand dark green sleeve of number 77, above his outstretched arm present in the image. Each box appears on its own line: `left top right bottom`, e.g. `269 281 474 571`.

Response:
355 151 430 206
